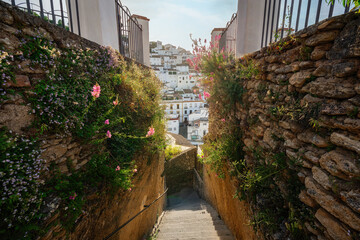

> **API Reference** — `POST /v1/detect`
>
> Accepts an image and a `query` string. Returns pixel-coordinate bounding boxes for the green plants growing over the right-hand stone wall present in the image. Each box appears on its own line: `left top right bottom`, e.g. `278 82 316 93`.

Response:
195 38 312 236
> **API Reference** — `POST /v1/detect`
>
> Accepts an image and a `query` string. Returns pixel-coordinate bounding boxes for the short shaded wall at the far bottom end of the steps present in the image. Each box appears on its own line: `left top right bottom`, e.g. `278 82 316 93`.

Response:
164 147 197 194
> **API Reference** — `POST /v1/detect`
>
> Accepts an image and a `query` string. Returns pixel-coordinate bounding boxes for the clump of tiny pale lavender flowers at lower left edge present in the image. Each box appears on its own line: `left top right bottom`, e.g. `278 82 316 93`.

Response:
0 128 44 239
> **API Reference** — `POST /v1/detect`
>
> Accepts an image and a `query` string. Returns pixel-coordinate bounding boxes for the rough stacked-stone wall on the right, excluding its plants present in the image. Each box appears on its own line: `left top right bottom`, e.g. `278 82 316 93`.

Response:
204 10 360 239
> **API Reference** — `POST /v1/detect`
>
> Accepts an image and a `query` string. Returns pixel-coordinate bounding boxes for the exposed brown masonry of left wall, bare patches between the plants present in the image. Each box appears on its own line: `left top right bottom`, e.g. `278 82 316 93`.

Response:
0 1 165 239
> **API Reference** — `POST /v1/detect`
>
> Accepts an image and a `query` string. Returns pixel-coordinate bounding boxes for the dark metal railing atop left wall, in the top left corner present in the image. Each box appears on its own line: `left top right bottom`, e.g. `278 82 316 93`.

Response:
2 0 81 36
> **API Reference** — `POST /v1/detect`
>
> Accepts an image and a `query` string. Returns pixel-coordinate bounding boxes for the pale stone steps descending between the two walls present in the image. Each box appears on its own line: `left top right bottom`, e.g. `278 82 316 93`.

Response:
156 189 235 240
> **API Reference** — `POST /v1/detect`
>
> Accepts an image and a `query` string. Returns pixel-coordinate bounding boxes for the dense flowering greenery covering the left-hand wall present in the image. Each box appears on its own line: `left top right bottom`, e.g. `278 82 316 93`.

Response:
0 33 165 239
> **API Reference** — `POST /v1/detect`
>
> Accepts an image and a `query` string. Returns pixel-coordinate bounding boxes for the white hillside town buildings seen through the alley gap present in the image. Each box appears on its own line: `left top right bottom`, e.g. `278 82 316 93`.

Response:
150 41 209 145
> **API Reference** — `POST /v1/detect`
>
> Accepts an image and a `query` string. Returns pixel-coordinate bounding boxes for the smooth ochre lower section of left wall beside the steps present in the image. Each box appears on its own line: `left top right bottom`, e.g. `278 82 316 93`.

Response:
40 155 166 240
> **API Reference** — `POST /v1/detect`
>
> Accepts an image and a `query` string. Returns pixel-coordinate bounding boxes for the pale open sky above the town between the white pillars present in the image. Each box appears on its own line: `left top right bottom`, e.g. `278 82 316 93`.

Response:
121 0 238 50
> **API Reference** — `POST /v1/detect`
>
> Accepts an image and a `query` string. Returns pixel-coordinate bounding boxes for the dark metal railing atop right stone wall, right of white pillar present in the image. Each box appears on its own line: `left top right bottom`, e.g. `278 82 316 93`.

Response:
261 0 352 47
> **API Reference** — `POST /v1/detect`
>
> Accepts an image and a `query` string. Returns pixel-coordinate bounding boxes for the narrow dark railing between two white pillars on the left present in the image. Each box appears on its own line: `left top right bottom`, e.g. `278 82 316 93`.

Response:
115 0 144 63
